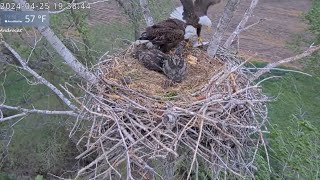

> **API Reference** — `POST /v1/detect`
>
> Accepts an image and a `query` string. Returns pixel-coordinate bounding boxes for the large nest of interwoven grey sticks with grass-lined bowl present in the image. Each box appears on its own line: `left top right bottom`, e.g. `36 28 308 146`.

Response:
77 47 268 179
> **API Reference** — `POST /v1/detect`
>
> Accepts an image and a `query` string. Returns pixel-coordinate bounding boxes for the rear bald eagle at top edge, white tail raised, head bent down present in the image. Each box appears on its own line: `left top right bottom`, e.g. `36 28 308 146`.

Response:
170 0 221 42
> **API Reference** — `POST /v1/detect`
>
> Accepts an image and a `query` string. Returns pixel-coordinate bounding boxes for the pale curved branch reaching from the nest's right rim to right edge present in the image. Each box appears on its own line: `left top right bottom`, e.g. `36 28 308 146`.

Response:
250 46 320 81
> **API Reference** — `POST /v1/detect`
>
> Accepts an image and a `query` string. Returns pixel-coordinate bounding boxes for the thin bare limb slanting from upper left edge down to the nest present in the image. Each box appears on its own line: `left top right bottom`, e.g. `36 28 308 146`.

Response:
2 41 77 111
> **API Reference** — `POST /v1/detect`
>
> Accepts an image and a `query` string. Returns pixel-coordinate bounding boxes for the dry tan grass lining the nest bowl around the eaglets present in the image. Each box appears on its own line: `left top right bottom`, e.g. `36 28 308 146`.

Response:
104 48 223 97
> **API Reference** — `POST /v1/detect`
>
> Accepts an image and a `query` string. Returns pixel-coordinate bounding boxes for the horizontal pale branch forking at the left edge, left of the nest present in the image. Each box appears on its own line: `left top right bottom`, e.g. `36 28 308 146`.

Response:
0 104 78 122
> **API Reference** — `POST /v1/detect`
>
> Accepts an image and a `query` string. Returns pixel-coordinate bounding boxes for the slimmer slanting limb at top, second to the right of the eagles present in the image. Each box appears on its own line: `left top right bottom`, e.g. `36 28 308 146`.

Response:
223 0 259 49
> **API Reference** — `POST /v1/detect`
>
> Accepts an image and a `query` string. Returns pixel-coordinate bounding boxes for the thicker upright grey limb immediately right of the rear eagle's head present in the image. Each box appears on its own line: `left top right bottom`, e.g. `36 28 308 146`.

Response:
207 0 240 57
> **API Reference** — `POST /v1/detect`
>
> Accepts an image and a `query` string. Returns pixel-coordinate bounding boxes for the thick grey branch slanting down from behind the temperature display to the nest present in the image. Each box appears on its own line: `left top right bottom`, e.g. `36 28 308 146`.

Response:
13 0 98 83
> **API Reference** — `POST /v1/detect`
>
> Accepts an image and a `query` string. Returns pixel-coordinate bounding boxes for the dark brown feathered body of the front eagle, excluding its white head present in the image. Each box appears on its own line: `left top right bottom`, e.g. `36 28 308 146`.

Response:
140 19 186 52
